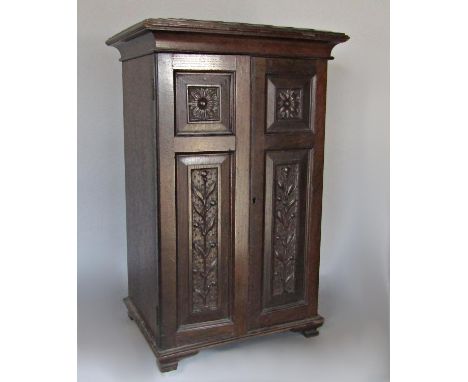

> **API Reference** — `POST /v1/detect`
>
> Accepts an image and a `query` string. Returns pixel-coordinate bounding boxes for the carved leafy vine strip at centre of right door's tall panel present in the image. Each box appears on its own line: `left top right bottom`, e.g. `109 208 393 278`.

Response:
273 164 299 296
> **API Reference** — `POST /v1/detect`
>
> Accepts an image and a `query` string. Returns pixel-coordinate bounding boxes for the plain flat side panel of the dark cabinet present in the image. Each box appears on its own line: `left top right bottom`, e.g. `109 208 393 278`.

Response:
122 55 159 336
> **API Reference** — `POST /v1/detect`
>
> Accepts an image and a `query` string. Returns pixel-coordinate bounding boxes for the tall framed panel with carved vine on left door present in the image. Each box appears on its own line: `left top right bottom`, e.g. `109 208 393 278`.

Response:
176 153 233 332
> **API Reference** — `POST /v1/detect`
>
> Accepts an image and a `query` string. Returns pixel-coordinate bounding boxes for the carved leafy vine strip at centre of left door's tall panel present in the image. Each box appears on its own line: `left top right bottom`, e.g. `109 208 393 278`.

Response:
191 168 218 312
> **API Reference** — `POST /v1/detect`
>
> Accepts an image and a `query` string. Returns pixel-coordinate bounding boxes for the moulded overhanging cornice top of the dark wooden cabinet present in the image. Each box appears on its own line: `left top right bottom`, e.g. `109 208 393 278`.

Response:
106 19 349 60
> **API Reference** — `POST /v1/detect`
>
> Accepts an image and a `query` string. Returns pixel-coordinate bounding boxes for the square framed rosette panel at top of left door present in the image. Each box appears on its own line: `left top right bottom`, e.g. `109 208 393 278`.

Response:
175 72 233 135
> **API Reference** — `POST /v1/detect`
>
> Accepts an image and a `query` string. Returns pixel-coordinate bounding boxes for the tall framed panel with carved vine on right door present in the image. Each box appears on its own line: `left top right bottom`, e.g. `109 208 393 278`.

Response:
262 150 310 311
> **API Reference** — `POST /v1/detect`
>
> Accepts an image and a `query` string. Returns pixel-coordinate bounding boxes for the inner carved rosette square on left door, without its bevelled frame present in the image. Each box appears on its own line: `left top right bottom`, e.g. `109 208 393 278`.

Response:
187 86 221 122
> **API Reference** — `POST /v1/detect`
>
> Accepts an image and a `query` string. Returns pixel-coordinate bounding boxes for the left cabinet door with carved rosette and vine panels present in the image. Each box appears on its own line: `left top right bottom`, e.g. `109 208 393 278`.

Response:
156 54 250 348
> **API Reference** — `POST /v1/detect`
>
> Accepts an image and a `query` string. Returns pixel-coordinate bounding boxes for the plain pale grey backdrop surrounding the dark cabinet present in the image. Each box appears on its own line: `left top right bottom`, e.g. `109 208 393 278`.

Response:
78 0 389 382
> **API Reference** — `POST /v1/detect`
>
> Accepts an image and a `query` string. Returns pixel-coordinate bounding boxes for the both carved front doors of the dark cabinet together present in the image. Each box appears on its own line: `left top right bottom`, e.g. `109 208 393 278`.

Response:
156 54 326 348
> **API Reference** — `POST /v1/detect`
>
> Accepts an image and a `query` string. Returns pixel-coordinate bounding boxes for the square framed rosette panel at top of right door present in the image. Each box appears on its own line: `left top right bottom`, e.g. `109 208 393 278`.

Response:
266 74 315 133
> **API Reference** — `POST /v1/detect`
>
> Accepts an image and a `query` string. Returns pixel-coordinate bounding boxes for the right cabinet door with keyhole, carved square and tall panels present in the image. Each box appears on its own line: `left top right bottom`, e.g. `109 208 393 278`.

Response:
249 58 326 330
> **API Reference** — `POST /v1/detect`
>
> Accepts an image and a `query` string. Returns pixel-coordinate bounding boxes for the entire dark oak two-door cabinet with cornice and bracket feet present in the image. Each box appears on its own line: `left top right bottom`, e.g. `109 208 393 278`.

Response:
107 19 348 371
